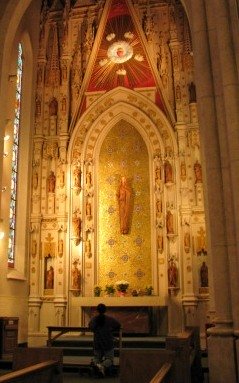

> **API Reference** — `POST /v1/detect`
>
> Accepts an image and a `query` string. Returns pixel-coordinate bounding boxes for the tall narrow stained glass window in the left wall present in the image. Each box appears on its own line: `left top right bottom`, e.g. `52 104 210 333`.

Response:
8 44 23 267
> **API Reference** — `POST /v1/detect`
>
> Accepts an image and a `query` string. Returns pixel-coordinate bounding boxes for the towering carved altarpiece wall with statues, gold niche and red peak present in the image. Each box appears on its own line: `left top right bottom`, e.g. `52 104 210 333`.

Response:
29 0 208 343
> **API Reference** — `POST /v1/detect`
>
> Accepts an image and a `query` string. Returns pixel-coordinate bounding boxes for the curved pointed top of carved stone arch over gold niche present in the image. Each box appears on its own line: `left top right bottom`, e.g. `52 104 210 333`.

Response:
69 87 177 163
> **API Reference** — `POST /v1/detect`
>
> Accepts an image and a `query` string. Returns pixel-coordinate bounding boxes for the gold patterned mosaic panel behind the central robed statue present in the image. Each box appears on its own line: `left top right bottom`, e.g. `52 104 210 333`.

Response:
98 121 152 290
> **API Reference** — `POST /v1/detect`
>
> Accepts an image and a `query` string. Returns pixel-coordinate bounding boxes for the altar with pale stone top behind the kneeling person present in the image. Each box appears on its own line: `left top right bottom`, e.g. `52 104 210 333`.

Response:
79 296 166 335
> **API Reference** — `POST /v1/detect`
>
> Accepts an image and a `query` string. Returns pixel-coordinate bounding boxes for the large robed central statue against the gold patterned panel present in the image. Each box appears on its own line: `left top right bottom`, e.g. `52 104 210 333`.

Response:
117 177 131 234
